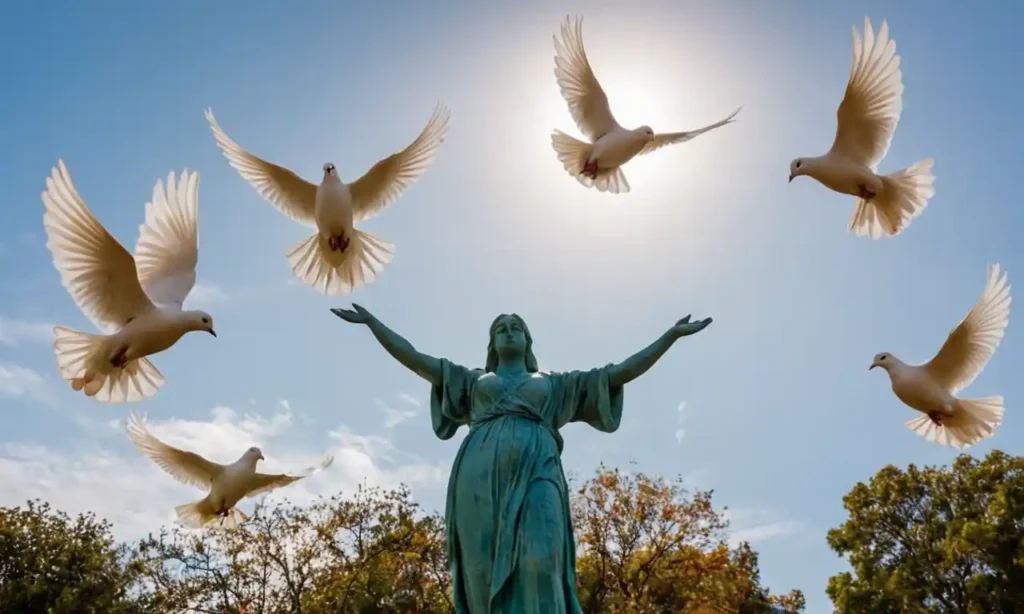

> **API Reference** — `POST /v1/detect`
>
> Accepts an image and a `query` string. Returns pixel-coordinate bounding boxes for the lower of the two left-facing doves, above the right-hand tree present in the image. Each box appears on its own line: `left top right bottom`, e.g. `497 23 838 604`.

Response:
868 264 1011 447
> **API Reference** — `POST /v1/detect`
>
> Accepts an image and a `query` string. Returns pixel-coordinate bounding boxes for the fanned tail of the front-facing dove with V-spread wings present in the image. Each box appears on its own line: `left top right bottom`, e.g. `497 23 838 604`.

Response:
287 228 394 296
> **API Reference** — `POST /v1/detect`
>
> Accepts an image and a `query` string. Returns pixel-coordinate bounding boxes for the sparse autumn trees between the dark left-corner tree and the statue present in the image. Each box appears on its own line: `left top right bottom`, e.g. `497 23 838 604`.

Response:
137 487 452 614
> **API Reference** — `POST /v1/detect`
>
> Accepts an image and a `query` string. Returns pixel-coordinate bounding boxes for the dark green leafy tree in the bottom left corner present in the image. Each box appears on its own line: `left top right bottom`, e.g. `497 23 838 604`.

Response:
0 500 144 614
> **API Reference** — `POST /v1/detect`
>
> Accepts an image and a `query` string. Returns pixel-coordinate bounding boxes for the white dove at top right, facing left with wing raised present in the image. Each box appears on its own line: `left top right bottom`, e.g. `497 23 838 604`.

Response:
790 17 935 238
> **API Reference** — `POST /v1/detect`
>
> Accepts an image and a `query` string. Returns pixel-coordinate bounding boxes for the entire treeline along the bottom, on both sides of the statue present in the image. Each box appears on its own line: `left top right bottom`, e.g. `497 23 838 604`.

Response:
6 451 1024 614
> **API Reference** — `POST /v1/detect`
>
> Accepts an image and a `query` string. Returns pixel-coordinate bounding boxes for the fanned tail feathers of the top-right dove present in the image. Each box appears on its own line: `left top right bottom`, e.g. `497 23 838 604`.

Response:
849 158 935 238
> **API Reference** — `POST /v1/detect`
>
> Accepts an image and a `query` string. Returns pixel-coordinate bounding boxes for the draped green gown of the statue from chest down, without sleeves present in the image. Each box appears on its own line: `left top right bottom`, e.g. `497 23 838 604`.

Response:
445 374 580 613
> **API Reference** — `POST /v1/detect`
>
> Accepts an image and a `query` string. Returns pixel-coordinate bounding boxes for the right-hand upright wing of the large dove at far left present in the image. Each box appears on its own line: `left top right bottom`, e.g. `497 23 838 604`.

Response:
135 170 199 309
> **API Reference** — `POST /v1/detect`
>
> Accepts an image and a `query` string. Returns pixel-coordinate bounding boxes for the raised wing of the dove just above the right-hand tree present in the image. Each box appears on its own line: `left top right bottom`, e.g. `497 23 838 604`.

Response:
923 264 1011 394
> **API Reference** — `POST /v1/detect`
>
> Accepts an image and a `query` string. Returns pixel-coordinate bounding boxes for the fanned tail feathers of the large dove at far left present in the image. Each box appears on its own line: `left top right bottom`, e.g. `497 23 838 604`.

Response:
53 326 164 403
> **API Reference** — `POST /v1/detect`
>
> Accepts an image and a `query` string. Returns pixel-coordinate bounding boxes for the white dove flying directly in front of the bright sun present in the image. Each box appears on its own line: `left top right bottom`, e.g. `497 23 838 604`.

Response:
551 17 740 194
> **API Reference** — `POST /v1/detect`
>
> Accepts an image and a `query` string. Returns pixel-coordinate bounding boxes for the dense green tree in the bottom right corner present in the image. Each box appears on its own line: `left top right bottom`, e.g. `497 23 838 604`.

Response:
827 450 1024 614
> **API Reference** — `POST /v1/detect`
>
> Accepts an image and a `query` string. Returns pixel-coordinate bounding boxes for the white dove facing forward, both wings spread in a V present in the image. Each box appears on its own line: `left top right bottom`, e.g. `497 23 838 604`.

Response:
206 104 450 296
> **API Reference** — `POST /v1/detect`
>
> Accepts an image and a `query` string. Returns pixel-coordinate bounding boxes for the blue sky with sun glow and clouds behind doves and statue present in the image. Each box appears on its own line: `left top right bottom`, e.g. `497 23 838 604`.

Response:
0 1 1024 612
